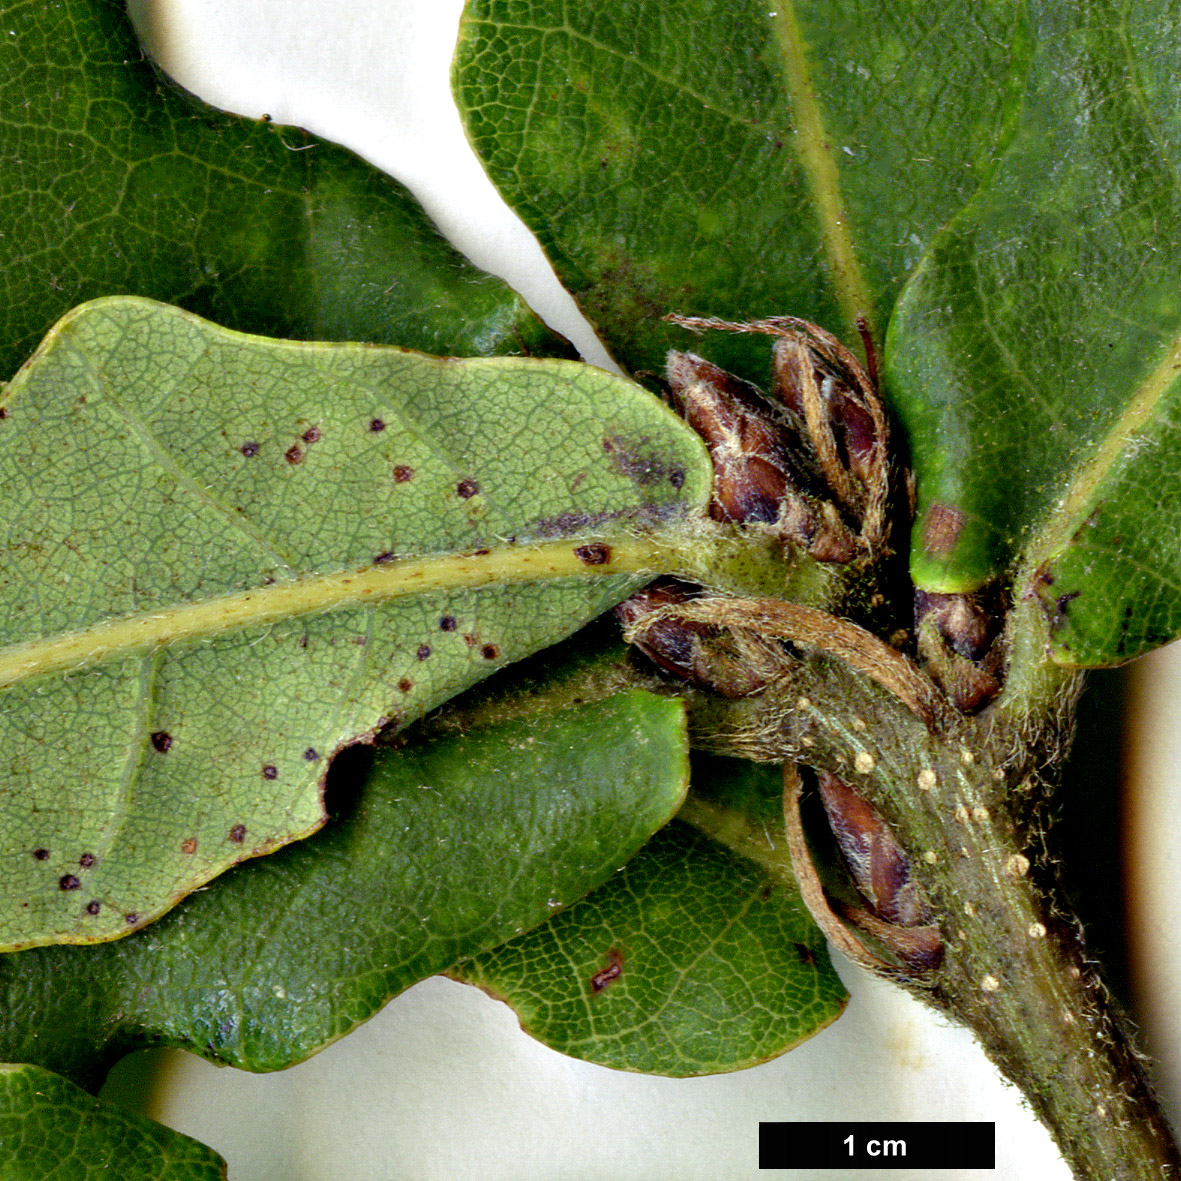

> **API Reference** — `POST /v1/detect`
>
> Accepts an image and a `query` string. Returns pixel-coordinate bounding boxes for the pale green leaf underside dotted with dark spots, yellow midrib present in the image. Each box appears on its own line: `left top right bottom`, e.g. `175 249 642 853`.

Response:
0 299 710 947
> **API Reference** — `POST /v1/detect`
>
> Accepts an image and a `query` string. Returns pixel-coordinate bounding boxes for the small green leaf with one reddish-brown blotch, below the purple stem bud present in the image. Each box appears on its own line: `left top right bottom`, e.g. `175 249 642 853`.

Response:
449 756 846 1076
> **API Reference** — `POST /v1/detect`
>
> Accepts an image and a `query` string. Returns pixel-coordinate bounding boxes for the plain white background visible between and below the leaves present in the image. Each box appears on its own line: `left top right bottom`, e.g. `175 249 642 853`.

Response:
96 0 1181 1181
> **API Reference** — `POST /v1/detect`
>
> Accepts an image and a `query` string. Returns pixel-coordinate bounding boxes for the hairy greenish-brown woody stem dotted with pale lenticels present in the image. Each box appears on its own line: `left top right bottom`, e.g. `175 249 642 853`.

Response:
694 652 1181 1181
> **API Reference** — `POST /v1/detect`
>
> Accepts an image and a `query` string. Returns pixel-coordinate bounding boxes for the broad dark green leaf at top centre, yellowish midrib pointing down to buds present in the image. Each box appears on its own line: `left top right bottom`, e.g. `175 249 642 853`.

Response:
455 0 1027 379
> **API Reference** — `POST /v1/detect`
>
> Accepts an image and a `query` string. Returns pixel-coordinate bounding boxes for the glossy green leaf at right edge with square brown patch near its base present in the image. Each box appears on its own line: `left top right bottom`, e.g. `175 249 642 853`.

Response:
889 0 1181 637
